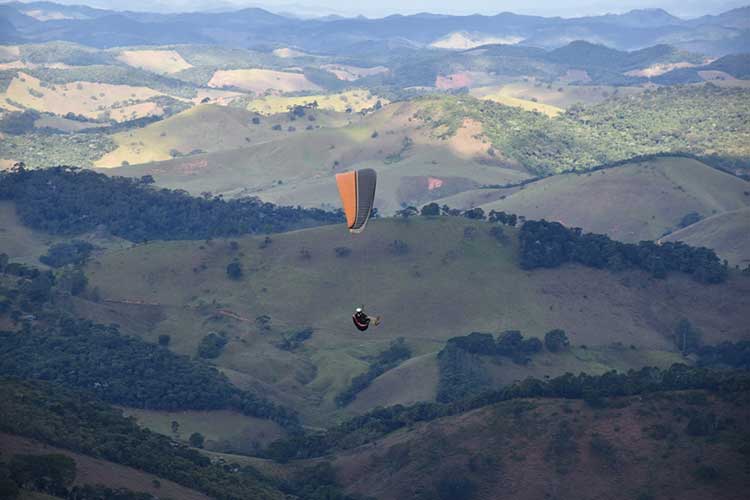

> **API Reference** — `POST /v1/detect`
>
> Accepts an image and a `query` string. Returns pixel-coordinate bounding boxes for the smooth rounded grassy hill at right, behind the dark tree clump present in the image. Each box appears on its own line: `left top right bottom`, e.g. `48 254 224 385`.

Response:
482 158 750 241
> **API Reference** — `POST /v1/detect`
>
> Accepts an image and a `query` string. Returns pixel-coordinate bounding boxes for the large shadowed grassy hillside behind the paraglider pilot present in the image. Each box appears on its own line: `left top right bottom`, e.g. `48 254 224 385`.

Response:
79 218 750 425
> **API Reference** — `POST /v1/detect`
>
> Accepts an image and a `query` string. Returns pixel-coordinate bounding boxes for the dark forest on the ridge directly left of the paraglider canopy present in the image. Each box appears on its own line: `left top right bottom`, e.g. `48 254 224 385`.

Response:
0 167 343 242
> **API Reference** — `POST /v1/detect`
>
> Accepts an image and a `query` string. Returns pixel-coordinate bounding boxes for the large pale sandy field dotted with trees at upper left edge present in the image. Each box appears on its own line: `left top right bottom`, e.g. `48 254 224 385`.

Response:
0 72 164 122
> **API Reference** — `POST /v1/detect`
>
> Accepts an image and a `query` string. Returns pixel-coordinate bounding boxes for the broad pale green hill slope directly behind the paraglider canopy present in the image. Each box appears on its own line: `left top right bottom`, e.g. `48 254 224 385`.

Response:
103 103 529 213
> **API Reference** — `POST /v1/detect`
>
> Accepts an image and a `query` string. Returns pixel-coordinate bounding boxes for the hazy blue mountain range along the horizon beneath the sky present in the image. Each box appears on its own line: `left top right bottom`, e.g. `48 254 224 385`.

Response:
0 2 750 56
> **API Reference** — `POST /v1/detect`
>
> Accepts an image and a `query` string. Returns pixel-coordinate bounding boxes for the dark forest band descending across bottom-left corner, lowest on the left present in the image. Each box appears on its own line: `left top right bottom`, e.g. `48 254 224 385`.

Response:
0 378 288 500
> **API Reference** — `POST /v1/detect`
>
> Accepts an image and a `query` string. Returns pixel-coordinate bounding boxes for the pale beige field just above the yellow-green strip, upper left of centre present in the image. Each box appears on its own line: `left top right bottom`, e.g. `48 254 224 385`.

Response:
208 69 322 94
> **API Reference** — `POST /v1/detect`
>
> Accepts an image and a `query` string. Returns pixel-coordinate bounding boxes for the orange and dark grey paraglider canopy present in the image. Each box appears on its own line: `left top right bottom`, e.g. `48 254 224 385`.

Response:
336 168 377 233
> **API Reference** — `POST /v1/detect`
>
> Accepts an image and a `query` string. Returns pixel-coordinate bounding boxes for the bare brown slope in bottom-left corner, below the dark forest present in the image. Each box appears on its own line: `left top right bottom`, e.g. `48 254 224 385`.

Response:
0 433 209 500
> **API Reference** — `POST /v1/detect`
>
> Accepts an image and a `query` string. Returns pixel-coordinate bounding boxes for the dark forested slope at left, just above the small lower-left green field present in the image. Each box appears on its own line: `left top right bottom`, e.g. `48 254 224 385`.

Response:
0 317 299 430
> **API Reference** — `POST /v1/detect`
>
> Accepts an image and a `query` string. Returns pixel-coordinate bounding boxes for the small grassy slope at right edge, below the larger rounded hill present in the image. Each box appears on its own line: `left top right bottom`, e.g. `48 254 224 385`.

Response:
662 208 750 267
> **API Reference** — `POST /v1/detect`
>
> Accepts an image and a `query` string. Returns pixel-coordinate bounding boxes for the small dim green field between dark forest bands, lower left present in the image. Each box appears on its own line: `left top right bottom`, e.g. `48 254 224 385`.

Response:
123 408 285 453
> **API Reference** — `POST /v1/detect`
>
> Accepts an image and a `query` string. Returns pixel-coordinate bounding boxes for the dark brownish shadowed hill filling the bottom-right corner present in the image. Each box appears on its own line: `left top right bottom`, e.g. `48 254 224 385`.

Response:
334 392 750 500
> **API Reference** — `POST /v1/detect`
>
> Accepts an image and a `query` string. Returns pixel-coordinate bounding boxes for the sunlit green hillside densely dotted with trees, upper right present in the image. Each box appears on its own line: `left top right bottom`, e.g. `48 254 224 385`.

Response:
418 85 750 175
